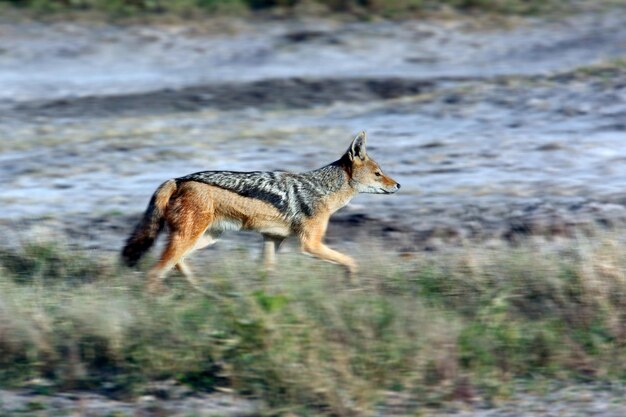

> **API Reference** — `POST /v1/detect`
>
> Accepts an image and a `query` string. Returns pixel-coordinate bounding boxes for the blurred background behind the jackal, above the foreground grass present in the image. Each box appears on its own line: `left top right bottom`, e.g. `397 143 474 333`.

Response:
0 0 626 251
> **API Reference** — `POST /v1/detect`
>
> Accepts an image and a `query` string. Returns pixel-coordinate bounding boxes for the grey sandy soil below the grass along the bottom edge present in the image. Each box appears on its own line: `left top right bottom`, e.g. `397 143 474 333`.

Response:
0 384 626 417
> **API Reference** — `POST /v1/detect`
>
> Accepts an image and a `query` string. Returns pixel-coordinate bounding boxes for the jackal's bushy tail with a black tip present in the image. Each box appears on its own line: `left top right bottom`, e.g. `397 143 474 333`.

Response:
122 180 176 266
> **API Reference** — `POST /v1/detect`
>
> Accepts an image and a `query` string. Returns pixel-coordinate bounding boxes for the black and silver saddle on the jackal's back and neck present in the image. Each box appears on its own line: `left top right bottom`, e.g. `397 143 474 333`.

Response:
176 162 354 223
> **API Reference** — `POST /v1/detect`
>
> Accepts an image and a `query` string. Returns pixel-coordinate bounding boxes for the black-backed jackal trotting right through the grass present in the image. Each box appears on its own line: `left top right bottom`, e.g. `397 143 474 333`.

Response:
122 132 400 292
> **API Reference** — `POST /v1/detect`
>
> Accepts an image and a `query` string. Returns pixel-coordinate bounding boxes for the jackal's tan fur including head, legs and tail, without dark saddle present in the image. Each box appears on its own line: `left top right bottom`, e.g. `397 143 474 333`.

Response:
123 132 400 292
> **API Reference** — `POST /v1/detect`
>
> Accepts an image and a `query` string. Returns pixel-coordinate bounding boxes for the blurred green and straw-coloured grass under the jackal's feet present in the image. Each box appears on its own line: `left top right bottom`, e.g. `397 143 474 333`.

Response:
0 236 626 415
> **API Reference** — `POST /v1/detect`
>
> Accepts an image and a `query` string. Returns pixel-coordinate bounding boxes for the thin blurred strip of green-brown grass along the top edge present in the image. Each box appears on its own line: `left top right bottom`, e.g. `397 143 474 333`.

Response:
0 0 606 17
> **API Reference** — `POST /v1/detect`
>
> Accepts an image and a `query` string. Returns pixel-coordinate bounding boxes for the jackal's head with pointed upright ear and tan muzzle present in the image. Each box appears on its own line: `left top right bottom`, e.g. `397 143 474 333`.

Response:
342 132 400 194
